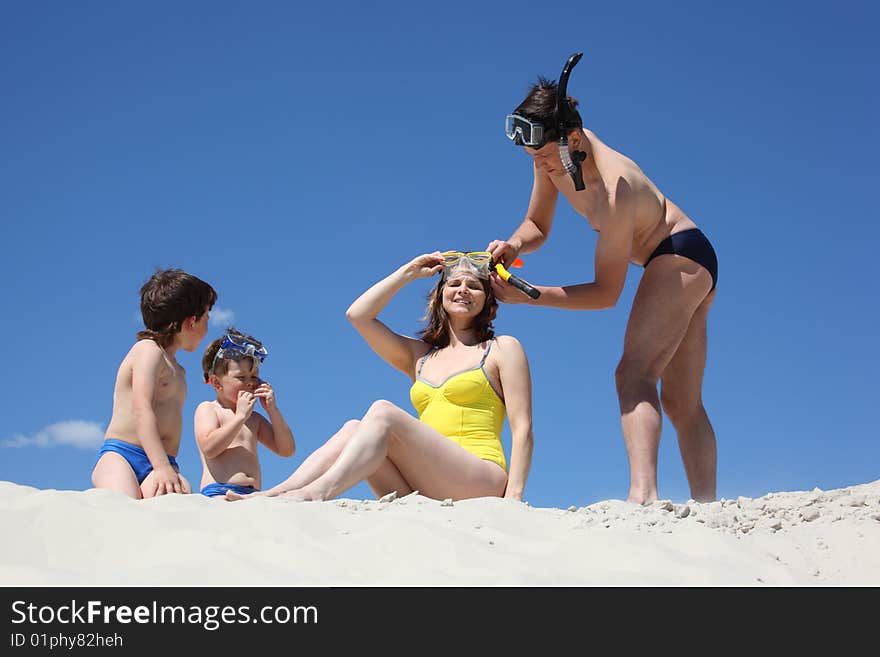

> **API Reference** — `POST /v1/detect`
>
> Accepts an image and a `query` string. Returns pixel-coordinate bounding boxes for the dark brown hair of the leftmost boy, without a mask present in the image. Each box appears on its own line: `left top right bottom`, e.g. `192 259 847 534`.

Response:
137 269 217 349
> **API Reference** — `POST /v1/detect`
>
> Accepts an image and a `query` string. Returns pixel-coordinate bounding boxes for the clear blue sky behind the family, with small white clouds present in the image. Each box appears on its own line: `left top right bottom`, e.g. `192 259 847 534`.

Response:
0 1 880 508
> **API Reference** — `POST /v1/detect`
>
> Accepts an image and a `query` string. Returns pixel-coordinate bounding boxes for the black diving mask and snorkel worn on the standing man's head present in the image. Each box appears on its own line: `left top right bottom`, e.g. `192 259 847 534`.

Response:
504 52 587 191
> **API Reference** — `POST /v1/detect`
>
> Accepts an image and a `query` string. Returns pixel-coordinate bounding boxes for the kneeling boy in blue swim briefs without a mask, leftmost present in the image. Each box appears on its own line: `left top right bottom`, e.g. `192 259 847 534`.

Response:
92 269 217 499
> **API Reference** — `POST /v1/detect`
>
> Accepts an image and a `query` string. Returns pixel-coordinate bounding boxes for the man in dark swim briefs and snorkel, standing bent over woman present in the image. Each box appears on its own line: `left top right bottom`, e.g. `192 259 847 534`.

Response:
487 53 718 503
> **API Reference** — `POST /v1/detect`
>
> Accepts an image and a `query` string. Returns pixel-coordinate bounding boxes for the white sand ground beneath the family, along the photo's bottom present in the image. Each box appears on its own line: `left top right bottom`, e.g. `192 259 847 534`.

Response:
0 480 880 586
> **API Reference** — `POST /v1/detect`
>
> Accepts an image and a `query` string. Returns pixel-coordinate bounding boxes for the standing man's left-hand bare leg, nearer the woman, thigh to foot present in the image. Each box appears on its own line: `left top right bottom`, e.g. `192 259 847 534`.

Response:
615 255 712 504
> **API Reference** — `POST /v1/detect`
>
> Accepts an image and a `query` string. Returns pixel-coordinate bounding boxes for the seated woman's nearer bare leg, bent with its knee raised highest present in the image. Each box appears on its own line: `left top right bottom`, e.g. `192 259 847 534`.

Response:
290 400 507 500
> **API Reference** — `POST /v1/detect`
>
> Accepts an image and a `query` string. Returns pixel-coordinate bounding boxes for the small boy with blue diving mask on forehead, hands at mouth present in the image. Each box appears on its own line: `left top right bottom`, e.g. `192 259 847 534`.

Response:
193 328 296 497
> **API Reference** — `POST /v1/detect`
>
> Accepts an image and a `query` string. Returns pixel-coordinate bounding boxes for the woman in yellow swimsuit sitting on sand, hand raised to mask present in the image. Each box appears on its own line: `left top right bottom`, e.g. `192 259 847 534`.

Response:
226 252 533 500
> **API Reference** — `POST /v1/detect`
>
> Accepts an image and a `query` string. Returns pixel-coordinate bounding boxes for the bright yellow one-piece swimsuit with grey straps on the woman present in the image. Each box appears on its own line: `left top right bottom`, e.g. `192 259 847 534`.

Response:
409 341 507 472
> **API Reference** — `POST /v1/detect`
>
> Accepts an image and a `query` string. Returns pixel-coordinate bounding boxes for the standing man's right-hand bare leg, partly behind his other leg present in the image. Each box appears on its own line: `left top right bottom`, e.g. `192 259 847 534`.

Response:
660 292 717 502
